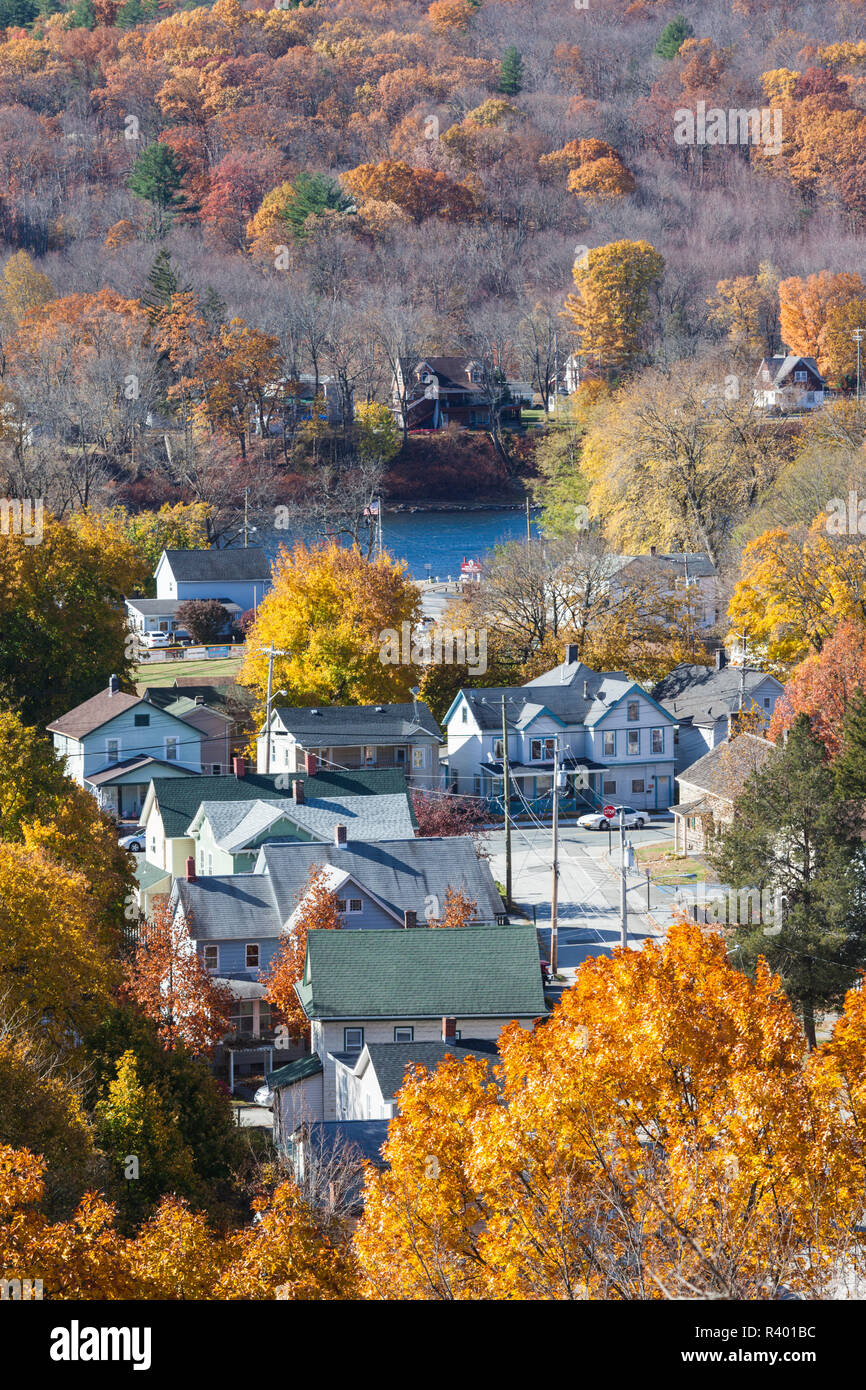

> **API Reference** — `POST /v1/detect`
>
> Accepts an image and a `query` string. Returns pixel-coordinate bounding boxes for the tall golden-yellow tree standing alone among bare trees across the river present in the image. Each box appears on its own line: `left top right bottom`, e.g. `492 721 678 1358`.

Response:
566 240 664 367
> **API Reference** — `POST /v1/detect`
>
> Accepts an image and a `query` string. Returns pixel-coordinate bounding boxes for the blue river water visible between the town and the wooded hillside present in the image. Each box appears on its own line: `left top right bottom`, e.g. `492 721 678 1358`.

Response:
256 507 538 580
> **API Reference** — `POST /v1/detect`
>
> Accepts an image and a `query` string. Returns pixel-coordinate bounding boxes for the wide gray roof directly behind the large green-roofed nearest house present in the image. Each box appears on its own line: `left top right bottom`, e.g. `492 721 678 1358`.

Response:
256 835 505 930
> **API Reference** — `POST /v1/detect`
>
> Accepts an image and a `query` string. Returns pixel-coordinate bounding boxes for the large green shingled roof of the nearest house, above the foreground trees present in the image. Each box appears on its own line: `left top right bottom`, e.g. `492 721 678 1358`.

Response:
296 926 546 1019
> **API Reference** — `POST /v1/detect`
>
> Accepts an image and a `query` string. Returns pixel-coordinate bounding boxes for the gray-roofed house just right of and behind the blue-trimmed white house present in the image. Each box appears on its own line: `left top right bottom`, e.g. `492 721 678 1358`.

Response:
652 651 784 776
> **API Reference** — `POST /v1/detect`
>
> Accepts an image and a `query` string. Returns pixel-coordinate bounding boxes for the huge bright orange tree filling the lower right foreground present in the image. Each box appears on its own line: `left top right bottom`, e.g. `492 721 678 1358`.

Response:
354 923 859 1301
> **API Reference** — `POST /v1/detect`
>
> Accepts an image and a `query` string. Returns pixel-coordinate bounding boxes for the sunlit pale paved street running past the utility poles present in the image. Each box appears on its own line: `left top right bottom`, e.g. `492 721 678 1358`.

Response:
487 821 673 980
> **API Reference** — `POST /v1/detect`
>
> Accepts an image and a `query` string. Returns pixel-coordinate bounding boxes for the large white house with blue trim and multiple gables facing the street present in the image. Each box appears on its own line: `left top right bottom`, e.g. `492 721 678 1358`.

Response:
442 646 676 812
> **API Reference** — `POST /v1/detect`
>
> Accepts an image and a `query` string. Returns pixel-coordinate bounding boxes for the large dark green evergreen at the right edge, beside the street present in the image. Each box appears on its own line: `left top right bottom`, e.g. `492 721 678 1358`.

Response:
708 714 866 1047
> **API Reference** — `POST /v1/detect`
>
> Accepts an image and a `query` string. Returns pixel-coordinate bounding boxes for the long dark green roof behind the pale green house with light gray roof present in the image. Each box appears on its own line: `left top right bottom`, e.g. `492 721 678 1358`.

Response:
142 767 406 840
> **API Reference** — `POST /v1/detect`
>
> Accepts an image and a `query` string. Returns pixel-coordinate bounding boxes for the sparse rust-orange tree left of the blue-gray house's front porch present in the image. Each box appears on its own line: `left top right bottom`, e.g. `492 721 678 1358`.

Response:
124 899 232 1055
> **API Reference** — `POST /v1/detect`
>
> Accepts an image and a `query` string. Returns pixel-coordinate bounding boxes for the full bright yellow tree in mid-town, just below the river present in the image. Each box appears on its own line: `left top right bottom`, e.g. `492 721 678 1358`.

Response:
239 542 420 705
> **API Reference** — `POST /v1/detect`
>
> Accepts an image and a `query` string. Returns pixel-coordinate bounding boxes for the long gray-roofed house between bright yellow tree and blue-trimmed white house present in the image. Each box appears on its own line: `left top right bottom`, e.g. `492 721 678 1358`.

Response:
256 701 443 787
